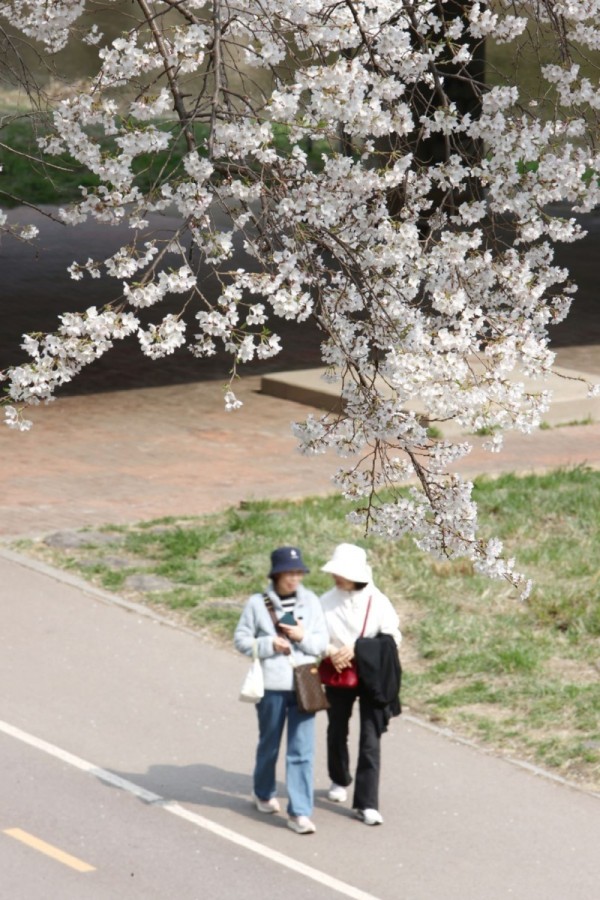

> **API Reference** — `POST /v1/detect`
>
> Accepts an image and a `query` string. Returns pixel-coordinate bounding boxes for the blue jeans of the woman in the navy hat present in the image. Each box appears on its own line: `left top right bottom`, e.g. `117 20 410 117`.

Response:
254 690 315 816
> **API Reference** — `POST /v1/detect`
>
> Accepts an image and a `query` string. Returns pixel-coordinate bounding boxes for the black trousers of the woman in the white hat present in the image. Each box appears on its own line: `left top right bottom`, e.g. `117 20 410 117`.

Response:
326 687 381 809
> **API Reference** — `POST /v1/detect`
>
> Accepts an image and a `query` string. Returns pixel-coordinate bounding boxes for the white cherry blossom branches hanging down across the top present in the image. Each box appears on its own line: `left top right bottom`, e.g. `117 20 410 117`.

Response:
0 0 600 595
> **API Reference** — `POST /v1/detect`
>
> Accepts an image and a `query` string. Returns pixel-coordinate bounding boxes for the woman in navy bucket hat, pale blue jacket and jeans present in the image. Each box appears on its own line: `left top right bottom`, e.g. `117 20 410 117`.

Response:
234 546 327 834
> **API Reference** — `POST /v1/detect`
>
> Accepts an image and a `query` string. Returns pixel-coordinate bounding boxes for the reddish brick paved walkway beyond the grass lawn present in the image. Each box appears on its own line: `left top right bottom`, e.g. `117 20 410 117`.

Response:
0 356 600 537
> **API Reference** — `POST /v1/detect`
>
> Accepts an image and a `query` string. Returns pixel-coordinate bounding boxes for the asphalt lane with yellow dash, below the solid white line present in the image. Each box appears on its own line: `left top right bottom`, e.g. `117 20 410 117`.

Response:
0 734 314 900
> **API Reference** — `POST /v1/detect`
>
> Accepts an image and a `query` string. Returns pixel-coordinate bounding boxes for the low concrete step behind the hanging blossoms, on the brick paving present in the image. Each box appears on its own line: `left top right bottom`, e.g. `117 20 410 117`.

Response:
261 366 600 437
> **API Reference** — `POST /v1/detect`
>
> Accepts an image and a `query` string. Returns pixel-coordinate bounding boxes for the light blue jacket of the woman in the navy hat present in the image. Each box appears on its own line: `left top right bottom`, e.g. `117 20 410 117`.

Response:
233 584 328 691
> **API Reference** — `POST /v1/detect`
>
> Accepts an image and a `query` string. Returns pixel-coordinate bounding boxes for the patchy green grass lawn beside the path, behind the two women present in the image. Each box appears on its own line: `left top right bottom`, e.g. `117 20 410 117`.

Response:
15 468 600 790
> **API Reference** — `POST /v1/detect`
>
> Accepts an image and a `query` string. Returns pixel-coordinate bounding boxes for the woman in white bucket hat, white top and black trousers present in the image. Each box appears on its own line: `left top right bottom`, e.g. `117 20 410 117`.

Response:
321 544 402 825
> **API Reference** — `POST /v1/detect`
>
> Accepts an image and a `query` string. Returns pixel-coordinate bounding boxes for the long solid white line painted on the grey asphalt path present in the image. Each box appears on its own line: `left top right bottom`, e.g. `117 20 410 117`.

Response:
0 720 379 900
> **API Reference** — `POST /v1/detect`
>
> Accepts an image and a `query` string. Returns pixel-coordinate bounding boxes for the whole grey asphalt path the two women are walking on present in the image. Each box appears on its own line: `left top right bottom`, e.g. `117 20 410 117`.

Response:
0 550 600 900
